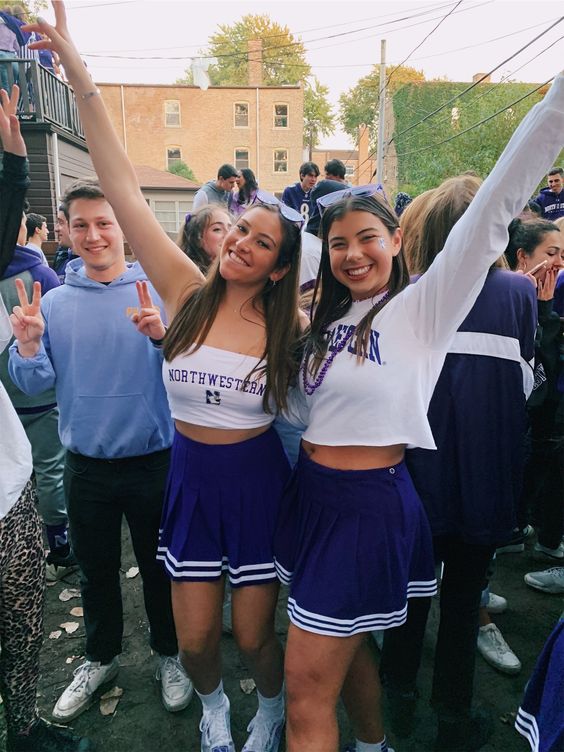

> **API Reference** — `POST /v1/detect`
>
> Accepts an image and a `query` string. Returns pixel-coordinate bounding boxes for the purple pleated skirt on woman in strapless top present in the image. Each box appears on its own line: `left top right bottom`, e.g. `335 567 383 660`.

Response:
157 428 290 587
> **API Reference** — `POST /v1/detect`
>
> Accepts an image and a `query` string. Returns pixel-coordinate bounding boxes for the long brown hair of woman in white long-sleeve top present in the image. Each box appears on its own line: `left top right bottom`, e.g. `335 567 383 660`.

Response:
304 195 409 375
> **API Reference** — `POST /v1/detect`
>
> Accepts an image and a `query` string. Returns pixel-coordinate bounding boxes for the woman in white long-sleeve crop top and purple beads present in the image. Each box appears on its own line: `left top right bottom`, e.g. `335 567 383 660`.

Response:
275 75 564 752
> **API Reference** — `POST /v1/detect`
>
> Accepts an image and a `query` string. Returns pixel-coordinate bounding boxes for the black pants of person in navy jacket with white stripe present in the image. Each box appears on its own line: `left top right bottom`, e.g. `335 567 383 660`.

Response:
380 535 495 714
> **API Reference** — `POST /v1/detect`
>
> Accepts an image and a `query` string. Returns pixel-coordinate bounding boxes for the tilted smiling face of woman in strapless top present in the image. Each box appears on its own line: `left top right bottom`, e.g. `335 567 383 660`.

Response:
219 206 287 287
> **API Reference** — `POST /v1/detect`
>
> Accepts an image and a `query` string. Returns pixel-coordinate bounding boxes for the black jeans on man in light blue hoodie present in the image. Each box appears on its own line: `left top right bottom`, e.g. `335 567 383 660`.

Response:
64 450 178 663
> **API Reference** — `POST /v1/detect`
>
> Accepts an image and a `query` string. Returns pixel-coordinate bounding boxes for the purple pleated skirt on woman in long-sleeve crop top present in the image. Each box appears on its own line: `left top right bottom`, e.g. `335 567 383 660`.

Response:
274 450 437 637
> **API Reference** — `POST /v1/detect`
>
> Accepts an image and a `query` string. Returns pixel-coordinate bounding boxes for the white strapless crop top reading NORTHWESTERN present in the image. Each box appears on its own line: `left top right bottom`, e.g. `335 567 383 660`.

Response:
163 345 274 429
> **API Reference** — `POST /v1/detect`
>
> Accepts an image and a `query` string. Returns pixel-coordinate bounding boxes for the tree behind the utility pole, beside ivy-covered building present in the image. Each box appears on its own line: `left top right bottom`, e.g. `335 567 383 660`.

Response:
339 65 425 142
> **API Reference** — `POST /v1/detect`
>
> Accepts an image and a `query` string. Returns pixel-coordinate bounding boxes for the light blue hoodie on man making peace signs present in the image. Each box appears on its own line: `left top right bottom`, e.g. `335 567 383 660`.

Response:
9 259 173 459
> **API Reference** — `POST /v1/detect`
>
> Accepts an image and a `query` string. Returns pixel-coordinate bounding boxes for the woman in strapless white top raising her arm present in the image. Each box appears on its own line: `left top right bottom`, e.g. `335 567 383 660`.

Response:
19 2 302 752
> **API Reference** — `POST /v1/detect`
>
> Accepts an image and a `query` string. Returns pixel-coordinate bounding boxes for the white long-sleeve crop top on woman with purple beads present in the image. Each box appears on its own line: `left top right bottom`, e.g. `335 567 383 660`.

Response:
286 75 564 449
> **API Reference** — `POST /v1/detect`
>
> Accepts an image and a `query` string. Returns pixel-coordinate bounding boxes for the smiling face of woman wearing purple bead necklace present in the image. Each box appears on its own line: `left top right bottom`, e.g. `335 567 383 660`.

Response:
327 211 402 300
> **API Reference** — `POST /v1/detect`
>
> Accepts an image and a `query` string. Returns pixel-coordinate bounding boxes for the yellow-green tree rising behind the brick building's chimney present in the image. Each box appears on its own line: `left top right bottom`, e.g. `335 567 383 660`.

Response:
177 13 334 146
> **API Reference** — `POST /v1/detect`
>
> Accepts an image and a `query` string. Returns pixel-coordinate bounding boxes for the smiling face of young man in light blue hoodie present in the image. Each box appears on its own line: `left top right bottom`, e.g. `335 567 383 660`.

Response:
69 198 126 282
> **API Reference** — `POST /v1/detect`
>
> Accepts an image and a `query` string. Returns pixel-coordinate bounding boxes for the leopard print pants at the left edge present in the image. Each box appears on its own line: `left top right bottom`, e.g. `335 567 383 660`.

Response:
0 482 45 734
